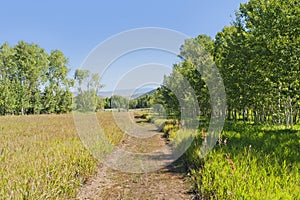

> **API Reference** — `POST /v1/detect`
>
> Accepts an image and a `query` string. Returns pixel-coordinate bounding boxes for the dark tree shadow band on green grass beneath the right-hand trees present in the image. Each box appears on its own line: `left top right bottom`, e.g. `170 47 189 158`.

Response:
222 122 300 163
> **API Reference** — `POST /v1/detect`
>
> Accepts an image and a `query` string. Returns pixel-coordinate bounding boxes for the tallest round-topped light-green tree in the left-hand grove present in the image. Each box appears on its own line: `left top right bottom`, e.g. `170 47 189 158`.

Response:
14 41 48 114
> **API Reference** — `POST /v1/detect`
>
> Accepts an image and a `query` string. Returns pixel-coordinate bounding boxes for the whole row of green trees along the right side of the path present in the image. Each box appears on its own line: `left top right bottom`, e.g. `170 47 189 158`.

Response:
155 0 300 126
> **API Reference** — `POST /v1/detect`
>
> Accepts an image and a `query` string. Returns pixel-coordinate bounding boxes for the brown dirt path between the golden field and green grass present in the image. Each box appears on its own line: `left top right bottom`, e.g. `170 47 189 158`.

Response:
77 115 193 200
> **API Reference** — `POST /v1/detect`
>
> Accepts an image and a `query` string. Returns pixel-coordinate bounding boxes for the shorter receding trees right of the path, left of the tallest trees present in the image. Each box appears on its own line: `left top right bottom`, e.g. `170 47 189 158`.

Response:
154 35 220 119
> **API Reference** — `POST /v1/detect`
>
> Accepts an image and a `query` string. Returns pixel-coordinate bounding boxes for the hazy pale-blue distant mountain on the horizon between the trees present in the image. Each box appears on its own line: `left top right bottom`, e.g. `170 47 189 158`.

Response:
99 88 156 99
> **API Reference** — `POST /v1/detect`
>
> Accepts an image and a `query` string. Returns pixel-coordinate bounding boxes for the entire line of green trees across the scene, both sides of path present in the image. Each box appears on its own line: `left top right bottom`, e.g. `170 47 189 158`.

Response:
0 0 300 126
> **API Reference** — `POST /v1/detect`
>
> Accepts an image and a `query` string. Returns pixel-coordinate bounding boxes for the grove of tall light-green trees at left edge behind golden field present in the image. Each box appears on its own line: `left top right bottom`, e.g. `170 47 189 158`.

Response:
0 41 73 115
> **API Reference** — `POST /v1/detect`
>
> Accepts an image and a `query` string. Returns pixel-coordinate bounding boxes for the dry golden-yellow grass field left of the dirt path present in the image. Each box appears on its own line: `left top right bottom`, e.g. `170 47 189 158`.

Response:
0 113 122 199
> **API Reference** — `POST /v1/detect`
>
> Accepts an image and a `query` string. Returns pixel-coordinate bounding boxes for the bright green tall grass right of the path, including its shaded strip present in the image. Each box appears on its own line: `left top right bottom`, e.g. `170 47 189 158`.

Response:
185 122 300 199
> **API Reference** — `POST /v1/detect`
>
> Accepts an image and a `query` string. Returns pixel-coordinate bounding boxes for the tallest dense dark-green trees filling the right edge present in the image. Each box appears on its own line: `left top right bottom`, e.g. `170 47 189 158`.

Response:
214 0 300 126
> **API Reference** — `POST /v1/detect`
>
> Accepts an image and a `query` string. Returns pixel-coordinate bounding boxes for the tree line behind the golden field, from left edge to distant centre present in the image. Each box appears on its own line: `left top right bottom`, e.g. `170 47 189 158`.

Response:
0 44 154 115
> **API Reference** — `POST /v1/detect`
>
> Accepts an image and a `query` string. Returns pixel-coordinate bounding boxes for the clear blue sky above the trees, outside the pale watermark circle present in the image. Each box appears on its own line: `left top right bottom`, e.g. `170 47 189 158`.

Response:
0 0 246 90
